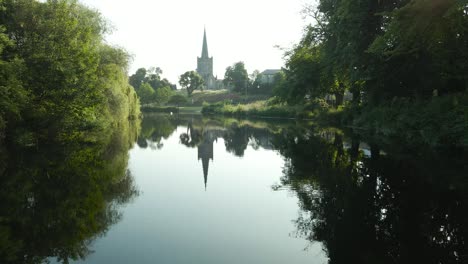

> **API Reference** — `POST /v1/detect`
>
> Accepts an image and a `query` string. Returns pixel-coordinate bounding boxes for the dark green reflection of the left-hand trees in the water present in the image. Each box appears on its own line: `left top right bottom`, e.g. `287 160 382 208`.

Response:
0 120 138 263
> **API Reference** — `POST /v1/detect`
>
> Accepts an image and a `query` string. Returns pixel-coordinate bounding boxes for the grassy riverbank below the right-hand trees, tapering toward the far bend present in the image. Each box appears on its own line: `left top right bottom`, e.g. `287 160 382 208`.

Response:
202 93 468 147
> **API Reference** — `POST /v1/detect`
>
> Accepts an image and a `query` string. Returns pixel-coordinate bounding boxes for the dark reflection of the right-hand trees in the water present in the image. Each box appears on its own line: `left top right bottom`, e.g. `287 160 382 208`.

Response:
275 126 468 263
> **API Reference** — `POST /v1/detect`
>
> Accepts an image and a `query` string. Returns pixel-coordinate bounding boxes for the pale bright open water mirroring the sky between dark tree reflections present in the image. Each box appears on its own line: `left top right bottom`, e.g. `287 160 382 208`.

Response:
75 118 327 263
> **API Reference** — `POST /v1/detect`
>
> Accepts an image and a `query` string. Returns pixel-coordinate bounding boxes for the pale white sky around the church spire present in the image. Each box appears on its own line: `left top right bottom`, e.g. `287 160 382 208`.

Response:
81 0 307 83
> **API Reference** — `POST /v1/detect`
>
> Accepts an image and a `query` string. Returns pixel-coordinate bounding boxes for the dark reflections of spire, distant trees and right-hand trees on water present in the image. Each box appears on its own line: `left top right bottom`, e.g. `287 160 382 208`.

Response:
138 116 468 263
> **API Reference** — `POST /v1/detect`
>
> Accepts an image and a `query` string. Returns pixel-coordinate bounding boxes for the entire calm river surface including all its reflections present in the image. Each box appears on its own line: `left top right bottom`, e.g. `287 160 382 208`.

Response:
0 115 468 264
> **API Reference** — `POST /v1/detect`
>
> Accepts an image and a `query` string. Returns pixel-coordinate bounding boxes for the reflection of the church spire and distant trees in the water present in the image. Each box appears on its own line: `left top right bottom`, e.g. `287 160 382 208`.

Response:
144 114 297 190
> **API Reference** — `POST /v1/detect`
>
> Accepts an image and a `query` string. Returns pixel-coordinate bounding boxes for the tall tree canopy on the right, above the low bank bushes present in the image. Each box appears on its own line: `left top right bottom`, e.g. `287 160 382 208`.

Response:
282 0 468 105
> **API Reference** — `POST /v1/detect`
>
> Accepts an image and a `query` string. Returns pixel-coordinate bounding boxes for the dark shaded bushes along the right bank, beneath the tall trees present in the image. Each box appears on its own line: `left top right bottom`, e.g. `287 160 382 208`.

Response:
348 94 468 147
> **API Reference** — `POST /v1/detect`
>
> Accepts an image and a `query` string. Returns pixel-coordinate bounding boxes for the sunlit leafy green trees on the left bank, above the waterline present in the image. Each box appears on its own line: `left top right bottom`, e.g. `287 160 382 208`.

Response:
0 0 140 145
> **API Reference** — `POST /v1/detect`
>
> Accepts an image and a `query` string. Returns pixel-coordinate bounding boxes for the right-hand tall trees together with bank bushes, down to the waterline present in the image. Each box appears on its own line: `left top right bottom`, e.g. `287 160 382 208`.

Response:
274 0 468 146
